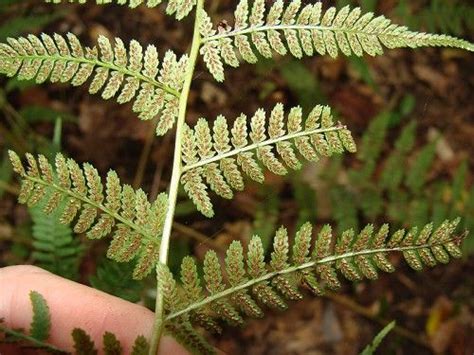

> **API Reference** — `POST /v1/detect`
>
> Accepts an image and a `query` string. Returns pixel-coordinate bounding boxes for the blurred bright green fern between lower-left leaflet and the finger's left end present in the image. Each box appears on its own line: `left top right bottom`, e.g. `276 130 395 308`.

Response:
29 201 83 280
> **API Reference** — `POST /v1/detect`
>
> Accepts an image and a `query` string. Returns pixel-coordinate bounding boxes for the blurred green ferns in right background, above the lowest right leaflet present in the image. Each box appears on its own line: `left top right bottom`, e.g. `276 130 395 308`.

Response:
323 97 474 253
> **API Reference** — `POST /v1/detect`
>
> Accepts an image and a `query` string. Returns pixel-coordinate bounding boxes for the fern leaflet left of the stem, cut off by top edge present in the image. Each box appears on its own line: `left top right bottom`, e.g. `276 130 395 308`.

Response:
45 0 196 20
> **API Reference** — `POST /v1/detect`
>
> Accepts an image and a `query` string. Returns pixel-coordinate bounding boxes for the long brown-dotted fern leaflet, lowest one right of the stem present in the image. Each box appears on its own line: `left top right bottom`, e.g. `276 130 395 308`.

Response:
158 219 464 354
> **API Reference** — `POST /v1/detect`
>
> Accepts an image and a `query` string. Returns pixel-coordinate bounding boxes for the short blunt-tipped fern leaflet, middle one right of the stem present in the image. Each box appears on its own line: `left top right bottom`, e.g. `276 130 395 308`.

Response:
181 104 356 217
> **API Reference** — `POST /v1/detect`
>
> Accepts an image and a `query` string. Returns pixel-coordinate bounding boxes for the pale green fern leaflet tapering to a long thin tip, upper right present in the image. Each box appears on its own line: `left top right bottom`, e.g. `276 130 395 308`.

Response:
201 0 474 81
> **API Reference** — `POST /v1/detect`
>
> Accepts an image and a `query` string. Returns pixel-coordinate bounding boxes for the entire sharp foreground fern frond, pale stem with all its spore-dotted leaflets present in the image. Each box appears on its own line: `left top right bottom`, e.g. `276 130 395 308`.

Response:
0 0 474 354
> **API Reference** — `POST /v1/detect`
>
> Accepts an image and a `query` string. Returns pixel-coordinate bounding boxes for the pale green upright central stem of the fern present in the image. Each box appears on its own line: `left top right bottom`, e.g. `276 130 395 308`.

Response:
149 0 204 355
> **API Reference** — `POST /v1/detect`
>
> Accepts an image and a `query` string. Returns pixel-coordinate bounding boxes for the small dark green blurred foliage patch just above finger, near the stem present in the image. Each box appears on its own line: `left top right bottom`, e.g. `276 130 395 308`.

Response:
89 259 143 303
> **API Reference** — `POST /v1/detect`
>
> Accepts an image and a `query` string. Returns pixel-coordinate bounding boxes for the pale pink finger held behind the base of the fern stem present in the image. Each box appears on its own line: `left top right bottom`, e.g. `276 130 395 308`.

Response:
0 266 188 355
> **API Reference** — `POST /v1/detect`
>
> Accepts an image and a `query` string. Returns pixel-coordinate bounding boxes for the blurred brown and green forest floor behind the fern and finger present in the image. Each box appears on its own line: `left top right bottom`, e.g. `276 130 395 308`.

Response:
0 0 474 354
